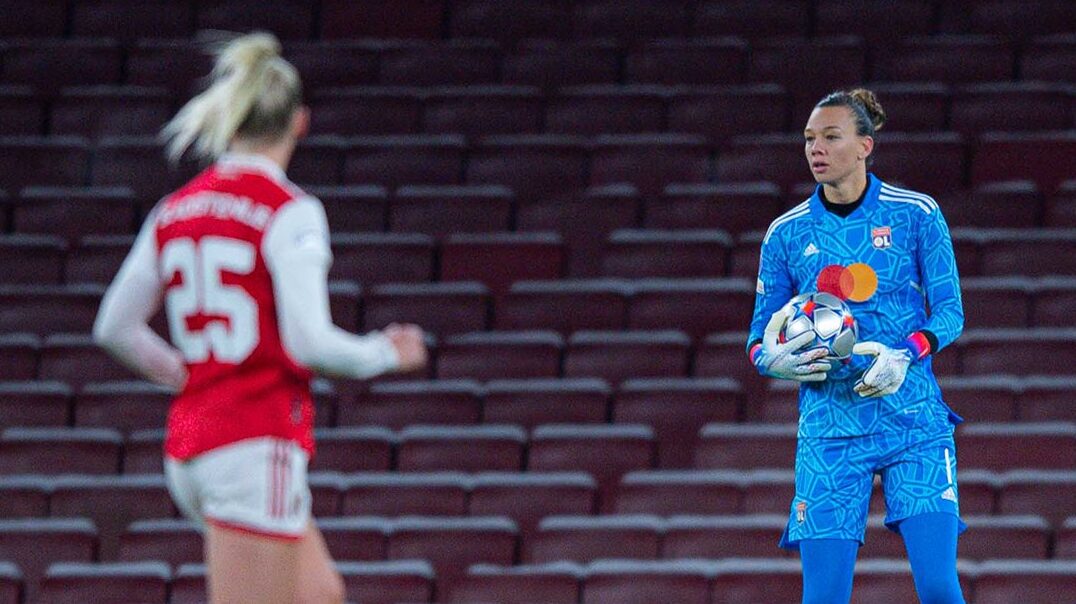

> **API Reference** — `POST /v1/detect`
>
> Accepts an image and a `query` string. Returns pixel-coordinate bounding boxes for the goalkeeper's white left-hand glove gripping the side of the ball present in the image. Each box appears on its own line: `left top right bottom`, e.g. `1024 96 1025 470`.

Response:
751 305 833 382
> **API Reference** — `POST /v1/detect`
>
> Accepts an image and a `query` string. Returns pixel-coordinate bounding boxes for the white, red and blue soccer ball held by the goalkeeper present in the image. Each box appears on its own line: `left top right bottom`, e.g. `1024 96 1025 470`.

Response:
779 292 860 362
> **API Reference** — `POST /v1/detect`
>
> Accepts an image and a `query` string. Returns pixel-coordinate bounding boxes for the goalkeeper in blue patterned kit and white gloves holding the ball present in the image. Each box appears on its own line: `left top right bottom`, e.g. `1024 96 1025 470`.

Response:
748 89 965 604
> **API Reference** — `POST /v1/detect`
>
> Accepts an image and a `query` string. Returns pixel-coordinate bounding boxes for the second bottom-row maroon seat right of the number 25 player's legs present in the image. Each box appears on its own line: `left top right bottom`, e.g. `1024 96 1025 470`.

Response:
447 562 583 604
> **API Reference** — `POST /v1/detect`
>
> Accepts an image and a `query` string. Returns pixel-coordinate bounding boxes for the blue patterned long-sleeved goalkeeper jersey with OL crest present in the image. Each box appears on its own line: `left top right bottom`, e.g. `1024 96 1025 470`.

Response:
748 174 964 437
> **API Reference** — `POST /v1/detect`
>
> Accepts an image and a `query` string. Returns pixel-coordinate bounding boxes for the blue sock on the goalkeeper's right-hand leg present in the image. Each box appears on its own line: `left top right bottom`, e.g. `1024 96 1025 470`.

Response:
897 511 964 604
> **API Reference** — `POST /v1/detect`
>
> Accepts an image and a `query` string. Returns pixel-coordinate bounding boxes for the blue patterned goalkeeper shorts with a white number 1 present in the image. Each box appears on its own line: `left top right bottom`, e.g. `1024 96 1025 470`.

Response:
779 430 967 549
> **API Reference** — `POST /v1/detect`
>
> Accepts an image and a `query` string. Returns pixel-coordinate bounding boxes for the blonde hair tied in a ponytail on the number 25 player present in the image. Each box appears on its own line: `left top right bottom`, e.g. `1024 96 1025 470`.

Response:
161 32 302 161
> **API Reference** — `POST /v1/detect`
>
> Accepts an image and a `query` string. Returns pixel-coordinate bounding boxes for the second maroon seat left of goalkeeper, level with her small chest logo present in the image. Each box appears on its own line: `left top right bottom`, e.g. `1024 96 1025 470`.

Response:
603 229 733 279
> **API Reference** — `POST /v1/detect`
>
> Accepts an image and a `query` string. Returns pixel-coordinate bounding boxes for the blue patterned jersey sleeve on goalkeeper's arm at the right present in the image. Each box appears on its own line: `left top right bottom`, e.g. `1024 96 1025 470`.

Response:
918 208 964 353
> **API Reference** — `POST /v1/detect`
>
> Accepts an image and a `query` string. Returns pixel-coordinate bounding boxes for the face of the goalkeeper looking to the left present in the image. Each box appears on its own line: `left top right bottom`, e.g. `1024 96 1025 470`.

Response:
804 106 873 184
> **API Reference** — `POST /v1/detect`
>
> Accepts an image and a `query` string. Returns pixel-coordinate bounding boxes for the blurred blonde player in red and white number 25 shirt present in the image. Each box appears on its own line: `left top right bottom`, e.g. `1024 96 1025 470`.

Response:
94 33 426 603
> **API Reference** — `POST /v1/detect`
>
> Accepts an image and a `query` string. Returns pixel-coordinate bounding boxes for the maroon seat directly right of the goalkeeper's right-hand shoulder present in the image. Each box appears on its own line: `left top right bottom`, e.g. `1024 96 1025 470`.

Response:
940 181 1043 228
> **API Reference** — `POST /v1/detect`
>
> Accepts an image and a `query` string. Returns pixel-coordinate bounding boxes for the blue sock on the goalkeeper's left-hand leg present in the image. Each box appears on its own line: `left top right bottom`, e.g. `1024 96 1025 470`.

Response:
799 539 860 604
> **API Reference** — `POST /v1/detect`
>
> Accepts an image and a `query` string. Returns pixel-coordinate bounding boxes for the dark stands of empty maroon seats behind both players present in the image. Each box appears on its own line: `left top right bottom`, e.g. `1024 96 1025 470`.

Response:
0 0 1076 604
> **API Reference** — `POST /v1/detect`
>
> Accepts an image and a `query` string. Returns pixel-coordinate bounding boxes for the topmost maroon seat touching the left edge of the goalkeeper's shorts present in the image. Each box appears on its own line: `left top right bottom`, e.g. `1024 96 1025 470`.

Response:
695 423 796 469
